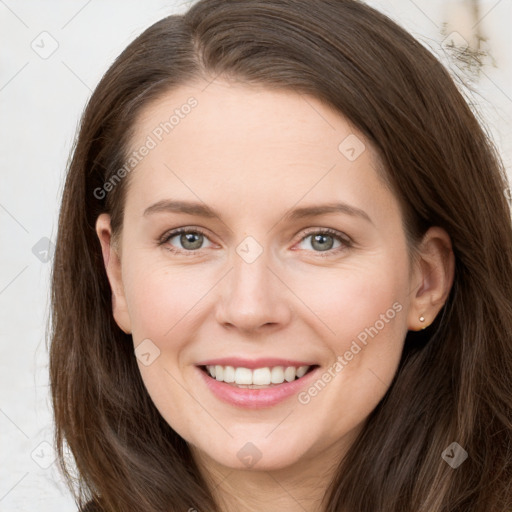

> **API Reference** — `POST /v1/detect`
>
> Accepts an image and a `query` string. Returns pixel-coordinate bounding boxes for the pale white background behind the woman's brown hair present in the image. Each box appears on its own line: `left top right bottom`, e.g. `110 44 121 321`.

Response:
0 0 512 512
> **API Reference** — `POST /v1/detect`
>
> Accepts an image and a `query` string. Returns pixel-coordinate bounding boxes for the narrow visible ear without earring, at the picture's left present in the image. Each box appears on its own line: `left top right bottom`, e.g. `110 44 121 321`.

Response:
96 213 131 334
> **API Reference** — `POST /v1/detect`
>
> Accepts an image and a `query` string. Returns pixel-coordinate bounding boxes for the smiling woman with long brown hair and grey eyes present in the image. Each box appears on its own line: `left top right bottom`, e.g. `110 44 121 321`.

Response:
50 0 512 512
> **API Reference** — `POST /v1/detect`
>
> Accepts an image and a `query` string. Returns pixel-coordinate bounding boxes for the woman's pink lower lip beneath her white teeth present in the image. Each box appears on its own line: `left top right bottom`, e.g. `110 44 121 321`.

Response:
197 367 320 409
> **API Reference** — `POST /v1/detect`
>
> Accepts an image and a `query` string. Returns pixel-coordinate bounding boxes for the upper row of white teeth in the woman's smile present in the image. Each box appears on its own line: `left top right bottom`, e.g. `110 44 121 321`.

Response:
206 365 310 387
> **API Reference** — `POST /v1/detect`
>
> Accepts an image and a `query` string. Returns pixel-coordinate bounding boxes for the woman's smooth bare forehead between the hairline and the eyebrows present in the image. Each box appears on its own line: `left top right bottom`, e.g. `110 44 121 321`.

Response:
122 81 390 222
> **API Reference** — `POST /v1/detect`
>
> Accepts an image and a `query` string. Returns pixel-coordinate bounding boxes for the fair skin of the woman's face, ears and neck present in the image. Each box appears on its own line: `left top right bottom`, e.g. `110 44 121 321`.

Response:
96 79 453 511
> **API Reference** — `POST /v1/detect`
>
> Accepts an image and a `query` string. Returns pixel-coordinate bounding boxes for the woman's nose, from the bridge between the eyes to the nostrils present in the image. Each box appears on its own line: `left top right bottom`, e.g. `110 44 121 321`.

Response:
217 237 290 330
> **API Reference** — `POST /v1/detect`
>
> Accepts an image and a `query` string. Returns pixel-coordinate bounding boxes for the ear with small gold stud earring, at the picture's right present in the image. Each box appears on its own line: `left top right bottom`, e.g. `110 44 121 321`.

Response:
408 227 455 331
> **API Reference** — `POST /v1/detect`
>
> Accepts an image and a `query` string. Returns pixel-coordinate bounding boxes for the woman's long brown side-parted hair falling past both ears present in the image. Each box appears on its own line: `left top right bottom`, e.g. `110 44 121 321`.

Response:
49 0 512 512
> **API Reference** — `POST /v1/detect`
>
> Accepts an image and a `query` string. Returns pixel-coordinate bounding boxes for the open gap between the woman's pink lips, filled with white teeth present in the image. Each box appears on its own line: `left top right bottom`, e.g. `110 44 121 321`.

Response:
198 364 319 389
